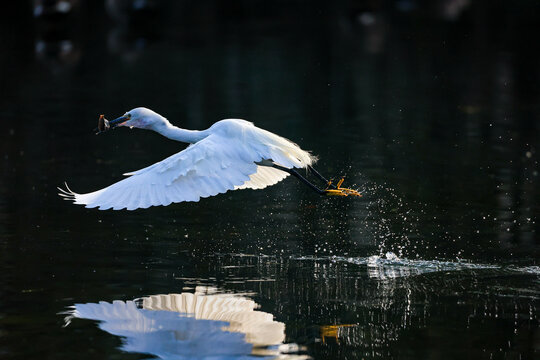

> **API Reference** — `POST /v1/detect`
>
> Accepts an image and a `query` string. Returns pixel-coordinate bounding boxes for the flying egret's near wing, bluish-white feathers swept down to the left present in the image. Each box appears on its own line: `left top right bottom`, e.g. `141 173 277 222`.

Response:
61 135 279 210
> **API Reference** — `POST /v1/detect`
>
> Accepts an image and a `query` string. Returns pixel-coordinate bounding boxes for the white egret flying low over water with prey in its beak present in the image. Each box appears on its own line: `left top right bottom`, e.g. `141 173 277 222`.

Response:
59 107 360 210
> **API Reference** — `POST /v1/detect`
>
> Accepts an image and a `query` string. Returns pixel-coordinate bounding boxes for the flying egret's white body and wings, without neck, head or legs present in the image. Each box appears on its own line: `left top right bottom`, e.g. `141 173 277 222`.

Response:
60 120 314 210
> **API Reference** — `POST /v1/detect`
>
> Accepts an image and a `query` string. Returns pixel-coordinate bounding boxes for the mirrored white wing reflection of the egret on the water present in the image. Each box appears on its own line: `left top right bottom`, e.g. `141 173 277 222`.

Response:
66 287 306 359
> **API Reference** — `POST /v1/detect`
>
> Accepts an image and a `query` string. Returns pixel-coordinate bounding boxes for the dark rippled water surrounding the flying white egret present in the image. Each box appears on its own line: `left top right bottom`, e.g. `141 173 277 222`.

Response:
0 1 540 359
